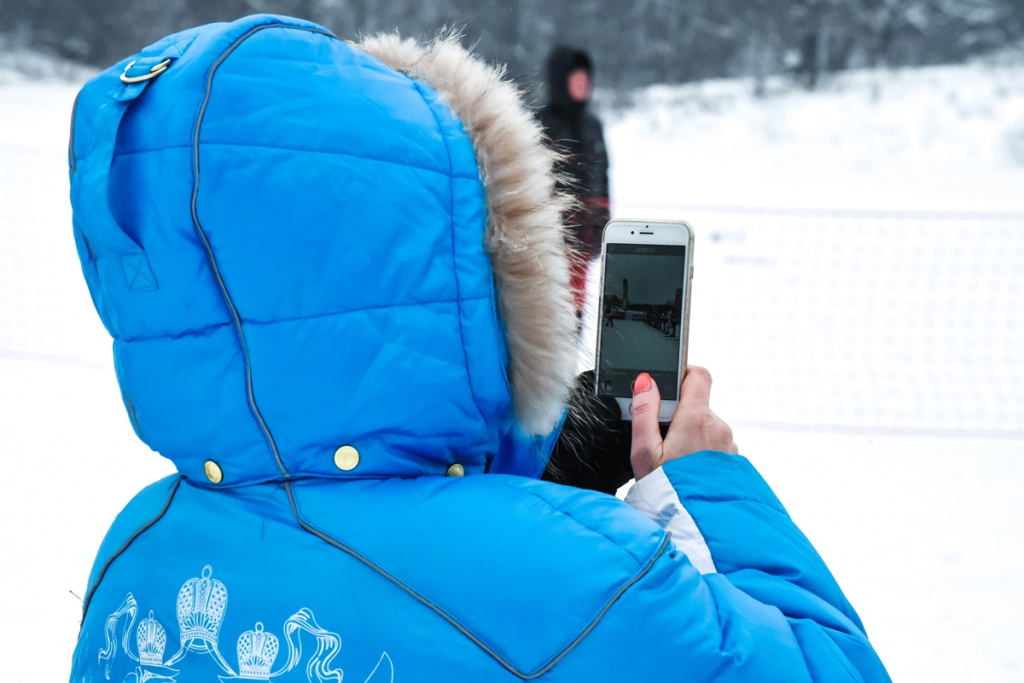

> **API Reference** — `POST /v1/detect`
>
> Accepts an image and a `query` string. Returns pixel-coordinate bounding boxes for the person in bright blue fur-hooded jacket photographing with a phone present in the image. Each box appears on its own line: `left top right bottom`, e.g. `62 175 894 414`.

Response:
70 15 888 683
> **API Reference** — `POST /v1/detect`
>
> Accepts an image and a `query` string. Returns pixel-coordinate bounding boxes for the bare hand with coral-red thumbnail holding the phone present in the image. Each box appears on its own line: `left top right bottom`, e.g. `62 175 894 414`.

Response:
630 366 739 479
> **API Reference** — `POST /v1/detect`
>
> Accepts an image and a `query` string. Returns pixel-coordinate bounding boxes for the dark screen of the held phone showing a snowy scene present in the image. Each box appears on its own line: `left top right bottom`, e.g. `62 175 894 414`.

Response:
597 243 687 400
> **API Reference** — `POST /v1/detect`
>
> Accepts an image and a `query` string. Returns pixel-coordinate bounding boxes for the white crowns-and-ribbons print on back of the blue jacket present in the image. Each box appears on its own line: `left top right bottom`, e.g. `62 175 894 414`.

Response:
98 564 394 683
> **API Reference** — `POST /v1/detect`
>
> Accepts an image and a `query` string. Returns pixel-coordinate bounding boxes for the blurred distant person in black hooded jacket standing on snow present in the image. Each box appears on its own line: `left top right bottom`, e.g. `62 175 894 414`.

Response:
540 46 610 314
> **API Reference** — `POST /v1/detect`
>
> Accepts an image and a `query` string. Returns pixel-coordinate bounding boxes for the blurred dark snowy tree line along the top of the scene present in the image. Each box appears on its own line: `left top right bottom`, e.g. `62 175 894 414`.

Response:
0 0 1024 90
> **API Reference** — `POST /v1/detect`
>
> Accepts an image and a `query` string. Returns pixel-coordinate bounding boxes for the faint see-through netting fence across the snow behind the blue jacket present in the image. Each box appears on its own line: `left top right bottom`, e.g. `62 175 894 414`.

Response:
6 145 1024 440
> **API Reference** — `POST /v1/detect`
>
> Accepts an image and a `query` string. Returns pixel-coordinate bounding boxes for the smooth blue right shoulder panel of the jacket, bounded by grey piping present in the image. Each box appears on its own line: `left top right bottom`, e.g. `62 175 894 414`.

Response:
295 475 671 677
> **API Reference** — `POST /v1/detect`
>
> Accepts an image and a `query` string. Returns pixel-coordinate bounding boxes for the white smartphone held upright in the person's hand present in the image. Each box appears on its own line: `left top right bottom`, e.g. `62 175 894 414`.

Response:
595 219 693 422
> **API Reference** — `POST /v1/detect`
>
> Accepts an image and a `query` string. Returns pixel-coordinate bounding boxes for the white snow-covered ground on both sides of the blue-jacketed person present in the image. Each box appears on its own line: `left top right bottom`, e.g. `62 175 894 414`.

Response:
6 55 1024 683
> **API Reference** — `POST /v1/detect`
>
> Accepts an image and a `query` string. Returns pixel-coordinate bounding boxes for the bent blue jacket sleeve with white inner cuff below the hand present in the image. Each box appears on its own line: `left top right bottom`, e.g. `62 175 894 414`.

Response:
624 452 890 682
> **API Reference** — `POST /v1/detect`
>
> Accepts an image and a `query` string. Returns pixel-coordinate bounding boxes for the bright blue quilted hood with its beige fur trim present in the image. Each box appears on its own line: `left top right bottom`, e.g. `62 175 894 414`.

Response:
71 15 578 485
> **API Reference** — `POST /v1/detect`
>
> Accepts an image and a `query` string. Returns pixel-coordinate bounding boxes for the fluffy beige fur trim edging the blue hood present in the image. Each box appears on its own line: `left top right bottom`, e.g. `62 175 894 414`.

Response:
352 34 579 434
